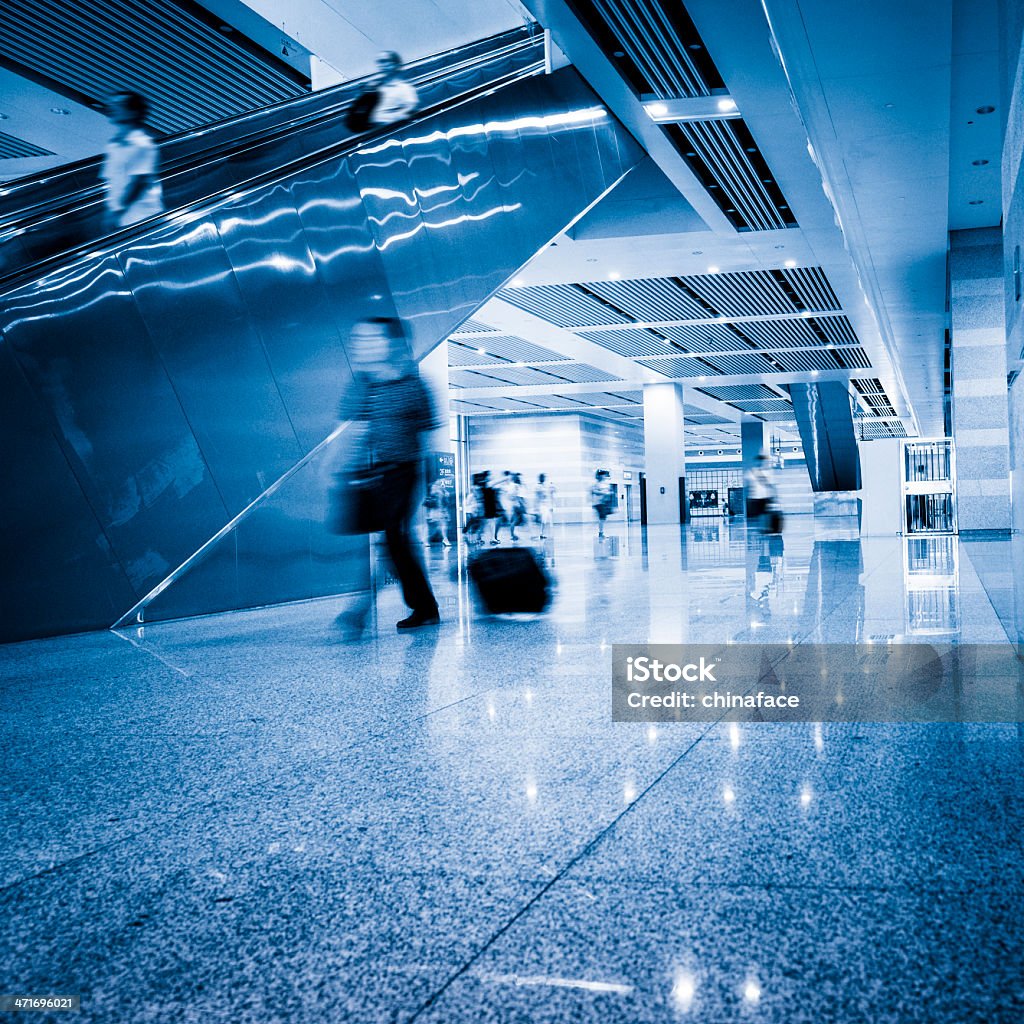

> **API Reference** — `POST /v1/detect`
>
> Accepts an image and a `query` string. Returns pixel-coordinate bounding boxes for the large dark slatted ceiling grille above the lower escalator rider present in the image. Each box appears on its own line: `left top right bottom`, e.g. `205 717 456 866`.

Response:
0 0 309 133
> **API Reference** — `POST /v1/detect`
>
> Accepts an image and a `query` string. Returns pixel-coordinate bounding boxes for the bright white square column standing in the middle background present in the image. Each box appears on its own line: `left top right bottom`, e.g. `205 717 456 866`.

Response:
643 383 686 525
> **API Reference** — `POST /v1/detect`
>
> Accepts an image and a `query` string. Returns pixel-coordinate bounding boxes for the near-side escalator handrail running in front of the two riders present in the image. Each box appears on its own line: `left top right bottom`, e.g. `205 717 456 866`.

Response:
0 41 546 295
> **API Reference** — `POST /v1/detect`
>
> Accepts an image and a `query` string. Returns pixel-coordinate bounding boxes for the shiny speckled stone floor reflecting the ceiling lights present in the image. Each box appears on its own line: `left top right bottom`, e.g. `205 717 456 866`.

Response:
0 517 1024 1024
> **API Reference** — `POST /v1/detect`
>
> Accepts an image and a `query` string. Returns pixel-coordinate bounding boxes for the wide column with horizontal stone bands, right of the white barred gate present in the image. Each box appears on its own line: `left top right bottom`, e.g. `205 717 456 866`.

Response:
949 227 1010 530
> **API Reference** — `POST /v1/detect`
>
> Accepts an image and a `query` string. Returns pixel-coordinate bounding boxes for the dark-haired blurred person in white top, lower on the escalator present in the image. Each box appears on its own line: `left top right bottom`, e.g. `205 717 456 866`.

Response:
100 92 164 231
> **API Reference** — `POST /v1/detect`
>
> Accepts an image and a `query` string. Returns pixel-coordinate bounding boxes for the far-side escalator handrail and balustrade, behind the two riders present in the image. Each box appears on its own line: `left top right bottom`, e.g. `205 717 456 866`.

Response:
0 27 538 232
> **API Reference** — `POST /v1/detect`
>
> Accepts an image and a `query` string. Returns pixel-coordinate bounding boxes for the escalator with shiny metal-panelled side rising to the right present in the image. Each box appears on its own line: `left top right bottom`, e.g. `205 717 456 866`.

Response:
0 29 641 641
